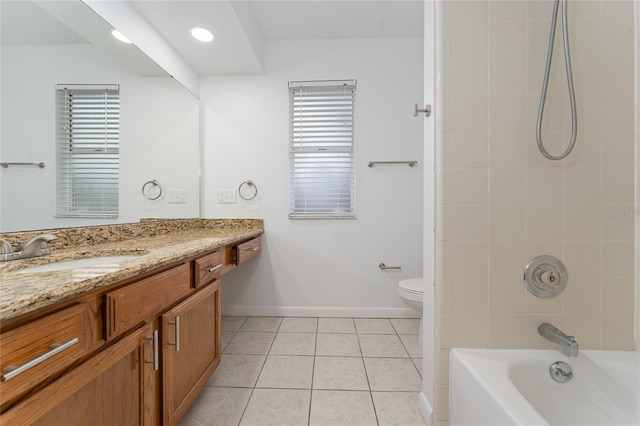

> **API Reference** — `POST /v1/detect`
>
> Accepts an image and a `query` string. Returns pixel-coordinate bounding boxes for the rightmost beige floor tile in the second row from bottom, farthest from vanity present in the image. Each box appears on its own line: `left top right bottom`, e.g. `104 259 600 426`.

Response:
364 358 422 392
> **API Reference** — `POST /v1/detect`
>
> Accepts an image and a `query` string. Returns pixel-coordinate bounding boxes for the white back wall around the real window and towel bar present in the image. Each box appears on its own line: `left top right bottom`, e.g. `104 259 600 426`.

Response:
201 38 424 317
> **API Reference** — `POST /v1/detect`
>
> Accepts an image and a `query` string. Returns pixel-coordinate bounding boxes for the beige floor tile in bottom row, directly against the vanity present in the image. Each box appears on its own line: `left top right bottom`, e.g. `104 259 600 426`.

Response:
180 387 251 426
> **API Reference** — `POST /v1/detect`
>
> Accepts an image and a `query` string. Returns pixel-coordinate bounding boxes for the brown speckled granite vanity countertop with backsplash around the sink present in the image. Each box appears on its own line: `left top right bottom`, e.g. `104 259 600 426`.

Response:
0 219 264 321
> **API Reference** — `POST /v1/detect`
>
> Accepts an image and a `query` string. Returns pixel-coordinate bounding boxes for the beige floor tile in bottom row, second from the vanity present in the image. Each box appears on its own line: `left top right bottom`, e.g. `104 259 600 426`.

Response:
240 389 311 426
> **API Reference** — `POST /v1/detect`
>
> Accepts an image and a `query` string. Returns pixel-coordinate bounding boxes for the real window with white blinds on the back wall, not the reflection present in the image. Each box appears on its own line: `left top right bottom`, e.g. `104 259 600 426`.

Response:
289 80 356 218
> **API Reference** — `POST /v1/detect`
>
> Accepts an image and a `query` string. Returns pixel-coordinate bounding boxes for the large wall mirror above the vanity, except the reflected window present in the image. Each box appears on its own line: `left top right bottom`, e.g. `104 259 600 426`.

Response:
0 0 200 232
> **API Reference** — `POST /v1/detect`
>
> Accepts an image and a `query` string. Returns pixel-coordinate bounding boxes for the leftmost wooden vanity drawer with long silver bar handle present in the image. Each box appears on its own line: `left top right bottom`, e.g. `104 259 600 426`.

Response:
0 304 91 407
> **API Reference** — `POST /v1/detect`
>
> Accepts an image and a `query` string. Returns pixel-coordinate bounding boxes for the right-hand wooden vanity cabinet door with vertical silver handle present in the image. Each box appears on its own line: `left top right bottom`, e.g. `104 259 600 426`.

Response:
162 280 220 425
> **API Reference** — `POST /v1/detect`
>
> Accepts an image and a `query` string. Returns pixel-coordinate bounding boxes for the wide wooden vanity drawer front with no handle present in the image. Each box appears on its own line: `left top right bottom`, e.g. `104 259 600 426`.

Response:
106 263 191 339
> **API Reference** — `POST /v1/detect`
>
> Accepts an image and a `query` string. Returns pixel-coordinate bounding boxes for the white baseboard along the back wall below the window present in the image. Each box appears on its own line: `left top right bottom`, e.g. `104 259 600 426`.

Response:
222 305 419 318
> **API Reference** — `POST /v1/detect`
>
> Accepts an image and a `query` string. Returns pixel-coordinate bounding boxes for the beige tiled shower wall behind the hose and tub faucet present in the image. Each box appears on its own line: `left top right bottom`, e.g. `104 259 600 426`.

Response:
435 0 638 423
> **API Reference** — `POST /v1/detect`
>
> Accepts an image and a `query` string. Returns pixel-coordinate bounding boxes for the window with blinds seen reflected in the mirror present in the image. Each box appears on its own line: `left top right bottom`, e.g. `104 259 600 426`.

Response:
56 84 120 217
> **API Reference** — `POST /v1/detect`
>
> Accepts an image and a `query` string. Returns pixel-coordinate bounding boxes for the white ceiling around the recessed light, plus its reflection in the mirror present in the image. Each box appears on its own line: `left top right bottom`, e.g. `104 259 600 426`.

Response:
0 0 423 76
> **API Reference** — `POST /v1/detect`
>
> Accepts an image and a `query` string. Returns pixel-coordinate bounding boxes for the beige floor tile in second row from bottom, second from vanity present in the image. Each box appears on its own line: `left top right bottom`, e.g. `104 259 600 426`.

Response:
256 355 313 389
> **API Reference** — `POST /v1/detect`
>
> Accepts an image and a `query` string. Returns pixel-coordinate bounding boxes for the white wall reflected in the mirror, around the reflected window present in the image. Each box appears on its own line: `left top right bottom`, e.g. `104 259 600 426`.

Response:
0 45 199 232
